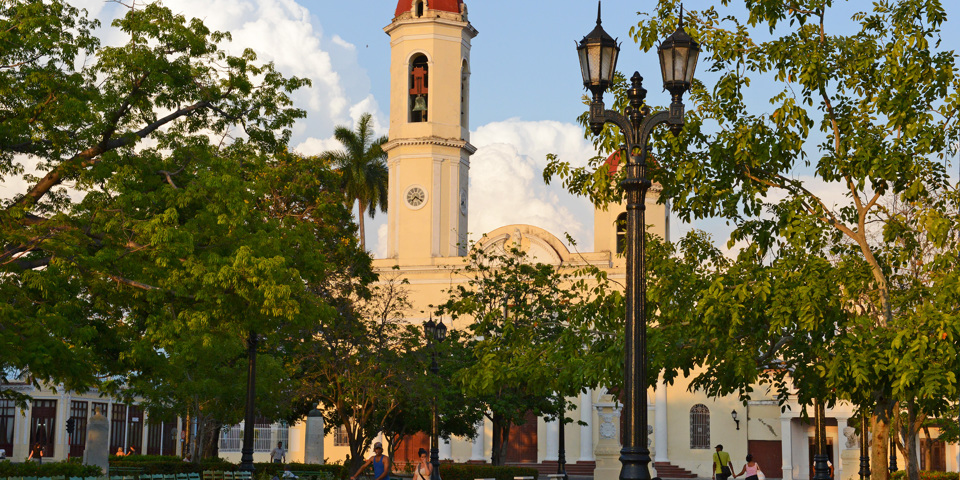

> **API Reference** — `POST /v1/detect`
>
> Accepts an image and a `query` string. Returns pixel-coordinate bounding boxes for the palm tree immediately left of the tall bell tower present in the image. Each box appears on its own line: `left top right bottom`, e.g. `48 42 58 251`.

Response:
321 113 389 250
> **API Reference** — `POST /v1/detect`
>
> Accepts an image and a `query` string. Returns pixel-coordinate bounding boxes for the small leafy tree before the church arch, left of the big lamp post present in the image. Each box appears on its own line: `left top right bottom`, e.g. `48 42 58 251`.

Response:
438 244 623 465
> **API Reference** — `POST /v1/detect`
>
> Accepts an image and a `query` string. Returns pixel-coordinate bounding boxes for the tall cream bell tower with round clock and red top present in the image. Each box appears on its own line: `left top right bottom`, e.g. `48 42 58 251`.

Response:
383 0 477 265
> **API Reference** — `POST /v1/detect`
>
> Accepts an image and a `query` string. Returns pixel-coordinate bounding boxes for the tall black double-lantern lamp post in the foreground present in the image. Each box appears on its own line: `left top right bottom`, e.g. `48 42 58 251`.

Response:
577 2 700 480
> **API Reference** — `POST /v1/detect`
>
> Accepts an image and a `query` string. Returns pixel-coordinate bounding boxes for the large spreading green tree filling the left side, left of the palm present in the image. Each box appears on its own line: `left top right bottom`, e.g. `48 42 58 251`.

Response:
0 0 382 456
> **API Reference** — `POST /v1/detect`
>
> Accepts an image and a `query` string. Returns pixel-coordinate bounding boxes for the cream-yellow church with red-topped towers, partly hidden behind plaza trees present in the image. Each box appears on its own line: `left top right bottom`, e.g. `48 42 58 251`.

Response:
291 0 957 480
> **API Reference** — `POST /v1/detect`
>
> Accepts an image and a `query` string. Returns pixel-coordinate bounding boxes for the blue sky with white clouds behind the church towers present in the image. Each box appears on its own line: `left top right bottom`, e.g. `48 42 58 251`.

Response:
50 0 960 256
